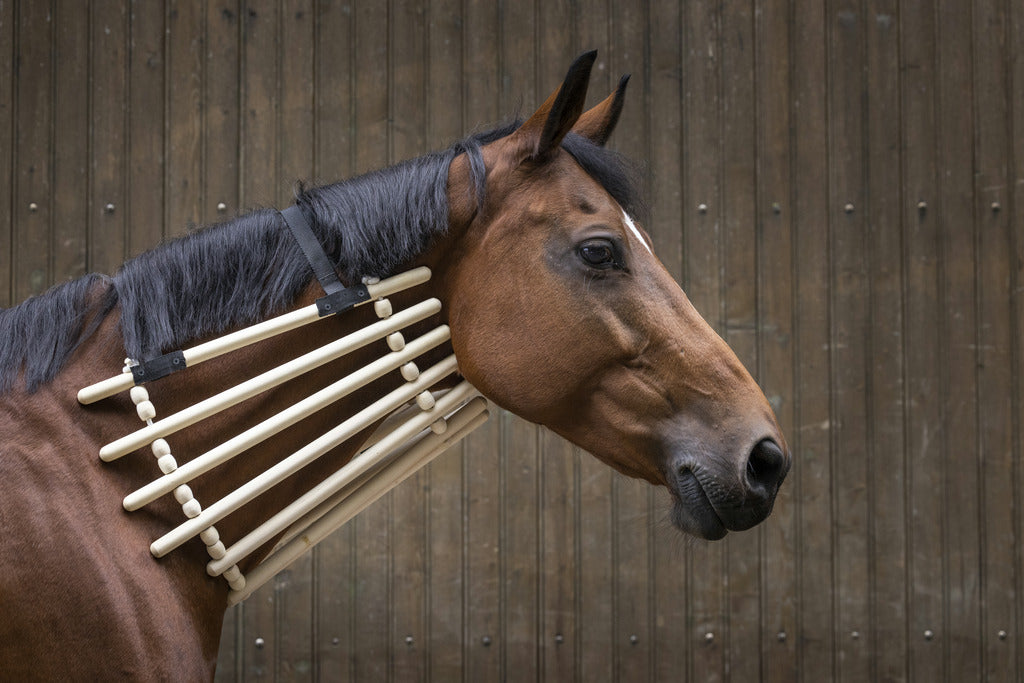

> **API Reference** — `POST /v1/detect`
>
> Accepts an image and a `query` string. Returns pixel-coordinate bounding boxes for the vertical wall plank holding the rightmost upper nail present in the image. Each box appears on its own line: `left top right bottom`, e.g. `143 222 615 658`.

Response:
970 0 1019 681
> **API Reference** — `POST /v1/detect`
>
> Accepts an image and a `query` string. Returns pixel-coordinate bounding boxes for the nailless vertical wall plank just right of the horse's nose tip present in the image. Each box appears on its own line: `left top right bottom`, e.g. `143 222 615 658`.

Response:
788 2 835 682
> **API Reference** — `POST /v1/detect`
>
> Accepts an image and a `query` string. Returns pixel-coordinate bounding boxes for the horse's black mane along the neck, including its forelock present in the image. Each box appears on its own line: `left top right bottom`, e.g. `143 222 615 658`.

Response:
0 123 641 392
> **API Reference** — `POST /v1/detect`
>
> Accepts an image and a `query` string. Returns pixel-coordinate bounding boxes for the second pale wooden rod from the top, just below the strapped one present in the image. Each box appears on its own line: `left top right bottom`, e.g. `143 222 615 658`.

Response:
99 299 441 462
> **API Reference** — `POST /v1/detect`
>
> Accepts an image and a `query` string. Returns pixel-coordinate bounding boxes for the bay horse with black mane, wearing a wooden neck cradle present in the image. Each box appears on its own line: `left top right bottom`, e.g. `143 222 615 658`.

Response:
0 52 792 680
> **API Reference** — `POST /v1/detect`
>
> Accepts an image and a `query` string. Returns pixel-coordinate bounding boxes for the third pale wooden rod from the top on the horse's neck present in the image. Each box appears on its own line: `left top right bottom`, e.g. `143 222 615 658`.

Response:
123 325 451 512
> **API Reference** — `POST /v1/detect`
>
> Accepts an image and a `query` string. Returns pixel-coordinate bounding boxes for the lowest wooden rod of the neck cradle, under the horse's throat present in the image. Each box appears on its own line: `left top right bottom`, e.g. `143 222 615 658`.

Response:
227 397 487 606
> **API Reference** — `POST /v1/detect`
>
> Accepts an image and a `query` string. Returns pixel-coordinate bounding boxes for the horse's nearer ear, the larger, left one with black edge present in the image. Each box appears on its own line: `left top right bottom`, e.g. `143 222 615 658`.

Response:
512 50 597 159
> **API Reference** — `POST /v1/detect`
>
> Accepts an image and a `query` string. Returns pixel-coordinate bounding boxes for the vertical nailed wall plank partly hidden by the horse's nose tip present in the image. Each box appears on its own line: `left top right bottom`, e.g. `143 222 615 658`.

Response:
749 2 799 681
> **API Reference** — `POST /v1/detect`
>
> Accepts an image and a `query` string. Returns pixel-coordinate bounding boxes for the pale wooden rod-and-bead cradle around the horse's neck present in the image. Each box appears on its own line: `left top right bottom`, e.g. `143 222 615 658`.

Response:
78 268 487 604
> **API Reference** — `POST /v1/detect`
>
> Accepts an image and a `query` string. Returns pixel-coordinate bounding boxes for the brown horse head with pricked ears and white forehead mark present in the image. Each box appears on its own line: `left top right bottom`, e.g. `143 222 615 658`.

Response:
434 52 791 539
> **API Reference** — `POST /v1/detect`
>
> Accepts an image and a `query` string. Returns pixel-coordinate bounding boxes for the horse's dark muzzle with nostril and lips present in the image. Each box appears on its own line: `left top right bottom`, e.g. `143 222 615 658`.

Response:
669 438 791 541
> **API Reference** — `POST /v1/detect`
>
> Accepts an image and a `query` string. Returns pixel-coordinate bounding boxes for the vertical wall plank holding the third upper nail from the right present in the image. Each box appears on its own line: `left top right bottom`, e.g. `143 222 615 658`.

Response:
827 1 871 681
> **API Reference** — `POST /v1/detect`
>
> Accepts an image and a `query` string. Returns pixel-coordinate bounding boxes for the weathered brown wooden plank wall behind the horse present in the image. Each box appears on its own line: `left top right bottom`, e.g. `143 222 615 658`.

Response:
0 0 1024 681
